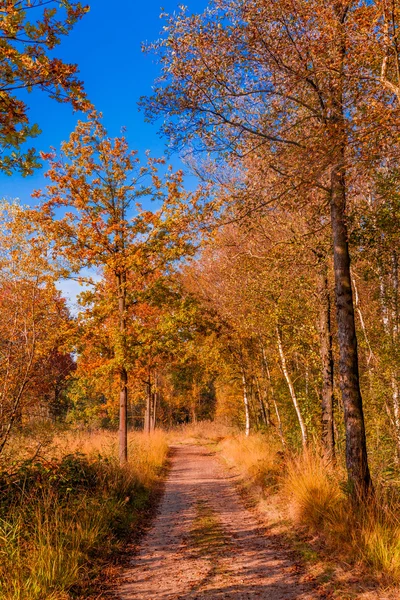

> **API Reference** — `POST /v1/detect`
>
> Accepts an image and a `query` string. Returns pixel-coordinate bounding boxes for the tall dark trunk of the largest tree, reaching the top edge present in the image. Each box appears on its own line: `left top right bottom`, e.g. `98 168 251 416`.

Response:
329 8 372 502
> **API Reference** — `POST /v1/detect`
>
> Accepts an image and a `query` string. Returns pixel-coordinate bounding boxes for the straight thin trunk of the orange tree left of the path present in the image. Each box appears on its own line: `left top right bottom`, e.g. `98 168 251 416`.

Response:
117 274 128 465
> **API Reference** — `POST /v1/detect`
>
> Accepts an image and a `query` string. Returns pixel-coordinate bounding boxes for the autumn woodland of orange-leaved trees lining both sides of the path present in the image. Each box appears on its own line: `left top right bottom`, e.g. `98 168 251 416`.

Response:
0 0 400 600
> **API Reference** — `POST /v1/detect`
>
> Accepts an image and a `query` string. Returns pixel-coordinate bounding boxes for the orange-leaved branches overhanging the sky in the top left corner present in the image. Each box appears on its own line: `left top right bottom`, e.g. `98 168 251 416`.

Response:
0 0 89 175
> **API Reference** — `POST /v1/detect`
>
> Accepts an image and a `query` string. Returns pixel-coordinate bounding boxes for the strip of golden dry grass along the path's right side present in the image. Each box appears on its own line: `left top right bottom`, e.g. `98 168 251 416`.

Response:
220 434 400 585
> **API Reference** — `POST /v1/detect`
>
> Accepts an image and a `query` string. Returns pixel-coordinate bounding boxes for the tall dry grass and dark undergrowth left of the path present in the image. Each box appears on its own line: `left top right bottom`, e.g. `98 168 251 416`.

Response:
0 432 168 600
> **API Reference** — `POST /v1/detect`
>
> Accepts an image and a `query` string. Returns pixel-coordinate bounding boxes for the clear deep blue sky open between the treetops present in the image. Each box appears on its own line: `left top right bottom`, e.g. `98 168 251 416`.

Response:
0 0 207 204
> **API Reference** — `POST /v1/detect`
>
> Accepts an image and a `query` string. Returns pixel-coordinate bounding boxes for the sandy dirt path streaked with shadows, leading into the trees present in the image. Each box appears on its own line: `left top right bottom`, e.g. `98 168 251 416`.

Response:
117 446 318 600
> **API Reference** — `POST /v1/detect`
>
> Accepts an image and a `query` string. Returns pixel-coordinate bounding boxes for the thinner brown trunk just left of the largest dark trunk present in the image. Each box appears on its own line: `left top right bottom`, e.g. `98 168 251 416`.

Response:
319 266 335 460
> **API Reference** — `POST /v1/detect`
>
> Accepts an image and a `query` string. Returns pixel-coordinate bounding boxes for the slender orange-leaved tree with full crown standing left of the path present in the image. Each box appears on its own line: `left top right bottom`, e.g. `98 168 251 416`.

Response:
36 113 195 463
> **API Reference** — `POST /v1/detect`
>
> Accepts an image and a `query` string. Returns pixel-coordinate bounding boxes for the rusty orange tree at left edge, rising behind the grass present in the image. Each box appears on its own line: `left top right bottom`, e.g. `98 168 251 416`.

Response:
0 201 73 453
